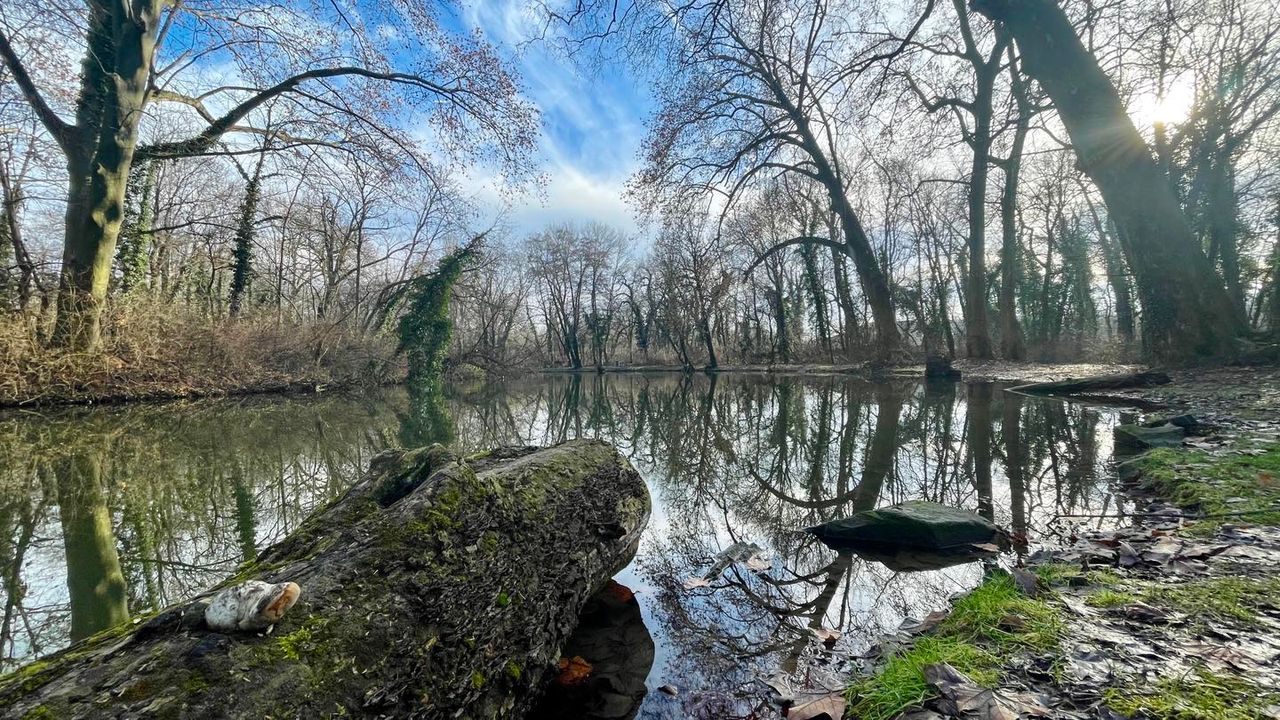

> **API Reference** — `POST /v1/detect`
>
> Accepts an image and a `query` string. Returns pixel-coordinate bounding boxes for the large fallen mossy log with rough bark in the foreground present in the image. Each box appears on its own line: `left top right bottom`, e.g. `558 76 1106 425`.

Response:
0 441 649 719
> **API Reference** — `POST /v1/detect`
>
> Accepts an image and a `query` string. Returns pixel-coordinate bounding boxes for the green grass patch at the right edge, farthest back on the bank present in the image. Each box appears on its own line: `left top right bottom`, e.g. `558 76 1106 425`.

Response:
1137 445 1280 534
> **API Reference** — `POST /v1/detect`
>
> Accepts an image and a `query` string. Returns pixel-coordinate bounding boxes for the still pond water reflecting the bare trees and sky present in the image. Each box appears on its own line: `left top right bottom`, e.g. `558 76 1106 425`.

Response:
0 374 1136 719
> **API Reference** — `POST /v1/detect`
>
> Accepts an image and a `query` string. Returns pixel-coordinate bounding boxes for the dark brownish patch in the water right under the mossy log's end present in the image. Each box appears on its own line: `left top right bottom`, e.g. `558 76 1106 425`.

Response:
529 580 654 720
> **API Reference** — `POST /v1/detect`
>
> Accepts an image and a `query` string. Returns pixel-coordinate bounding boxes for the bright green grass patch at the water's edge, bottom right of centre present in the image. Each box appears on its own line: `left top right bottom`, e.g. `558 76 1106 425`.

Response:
847 574 1064 720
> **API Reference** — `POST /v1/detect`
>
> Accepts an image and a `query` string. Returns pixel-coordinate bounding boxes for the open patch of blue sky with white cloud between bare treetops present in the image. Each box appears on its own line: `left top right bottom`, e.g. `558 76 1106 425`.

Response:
463 0 652 233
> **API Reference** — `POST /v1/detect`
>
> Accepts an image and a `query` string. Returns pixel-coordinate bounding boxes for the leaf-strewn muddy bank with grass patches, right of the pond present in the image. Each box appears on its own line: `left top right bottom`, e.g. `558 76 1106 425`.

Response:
847 368 1280 720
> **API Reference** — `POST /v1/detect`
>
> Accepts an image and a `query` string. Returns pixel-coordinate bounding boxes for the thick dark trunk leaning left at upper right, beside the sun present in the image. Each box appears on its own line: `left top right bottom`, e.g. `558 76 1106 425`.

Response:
970 0 1243 360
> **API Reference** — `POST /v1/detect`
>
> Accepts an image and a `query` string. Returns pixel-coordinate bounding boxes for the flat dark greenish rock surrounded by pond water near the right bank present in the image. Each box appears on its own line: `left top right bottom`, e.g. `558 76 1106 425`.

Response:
808 500 1005 551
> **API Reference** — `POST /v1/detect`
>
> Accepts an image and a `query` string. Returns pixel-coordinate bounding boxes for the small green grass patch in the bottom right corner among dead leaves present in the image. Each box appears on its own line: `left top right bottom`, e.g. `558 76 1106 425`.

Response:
1103 669 1280 720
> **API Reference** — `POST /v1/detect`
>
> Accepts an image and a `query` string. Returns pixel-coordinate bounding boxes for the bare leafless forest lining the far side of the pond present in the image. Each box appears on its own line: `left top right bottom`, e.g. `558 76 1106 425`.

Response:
0 0 1280 396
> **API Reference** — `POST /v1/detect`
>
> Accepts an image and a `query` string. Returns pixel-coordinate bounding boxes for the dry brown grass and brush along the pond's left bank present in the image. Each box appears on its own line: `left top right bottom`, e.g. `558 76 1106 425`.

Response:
0 304 401 406
